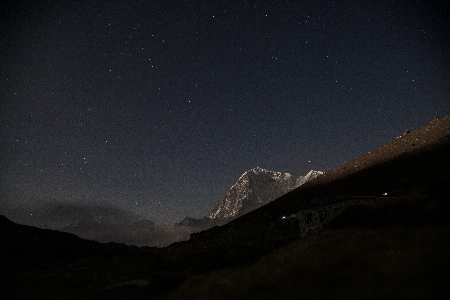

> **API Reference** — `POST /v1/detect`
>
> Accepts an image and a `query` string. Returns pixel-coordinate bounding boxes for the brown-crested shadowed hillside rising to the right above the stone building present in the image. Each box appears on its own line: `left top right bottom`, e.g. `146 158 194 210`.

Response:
232 116 450 224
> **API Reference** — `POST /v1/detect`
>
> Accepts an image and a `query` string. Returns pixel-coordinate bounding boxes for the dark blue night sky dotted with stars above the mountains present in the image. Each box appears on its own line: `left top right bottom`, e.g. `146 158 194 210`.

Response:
0 0 450 224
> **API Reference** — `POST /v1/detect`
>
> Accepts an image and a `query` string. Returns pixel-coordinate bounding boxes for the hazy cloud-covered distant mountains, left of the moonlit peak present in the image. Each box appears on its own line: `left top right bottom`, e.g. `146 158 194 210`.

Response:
32 203 189 247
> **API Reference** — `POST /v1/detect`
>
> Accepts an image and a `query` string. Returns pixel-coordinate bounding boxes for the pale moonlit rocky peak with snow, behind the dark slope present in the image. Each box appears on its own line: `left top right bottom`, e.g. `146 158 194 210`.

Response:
209 167 323 220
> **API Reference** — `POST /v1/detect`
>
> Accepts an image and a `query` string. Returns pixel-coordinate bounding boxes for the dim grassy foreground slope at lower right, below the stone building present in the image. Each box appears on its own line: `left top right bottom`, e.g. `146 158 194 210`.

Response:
162 189 450 299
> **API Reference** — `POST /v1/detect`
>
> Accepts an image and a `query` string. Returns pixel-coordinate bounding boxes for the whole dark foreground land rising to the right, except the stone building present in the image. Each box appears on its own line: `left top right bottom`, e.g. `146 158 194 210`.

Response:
0 117 450 299
